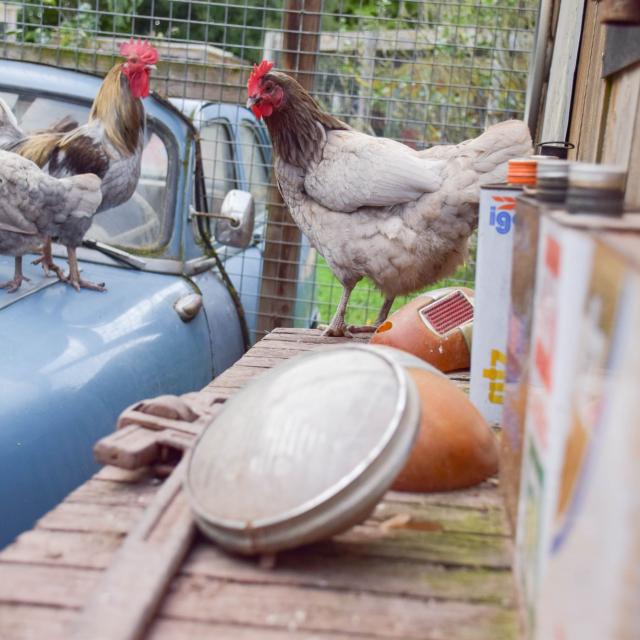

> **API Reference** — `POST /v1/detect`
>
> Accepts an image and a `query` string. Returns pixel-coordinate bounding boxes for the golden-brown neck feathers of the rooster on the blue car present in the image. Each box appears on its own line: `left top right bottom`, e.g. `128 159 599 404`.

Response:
89 64 144 155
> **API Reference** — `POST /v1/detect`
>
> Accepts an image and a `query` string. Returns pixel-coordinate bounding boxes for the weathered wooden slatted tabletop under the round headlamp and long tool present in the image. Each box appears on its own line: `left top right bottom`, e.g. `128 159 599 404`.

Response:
0 329 518 640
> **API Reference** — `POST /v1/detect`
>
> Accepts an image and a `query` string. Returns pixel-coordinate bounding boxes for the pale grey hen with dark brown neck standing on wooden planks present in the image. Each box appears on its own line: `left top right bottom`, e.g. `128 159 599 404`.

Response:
247 60 531 336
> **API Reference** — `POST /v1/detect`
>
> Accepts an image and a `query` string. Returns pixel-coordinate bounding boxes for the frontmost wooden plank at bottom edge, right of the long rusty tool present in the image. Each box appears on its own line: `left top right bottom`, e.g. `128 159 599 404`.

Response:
162 576 517 640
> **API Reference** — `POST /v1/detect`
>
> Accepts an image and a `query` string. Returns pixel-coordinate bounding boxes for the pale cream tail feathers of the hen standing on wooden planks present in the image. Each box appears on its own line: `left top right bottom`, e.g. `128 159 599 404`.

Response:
420 120 533 186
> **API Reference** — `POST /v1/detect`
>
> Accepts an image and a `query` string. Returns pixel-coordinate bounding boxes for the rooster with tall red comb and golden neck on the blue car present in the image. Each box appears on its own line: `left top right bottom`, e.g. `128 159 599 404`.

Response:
0 39 158 291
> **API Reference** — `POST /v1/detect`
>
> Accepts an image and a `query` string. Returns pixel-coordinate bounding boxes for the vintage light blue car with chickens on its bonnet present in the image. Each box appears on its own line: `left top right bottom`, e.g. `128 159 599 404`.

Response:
0 60 312 547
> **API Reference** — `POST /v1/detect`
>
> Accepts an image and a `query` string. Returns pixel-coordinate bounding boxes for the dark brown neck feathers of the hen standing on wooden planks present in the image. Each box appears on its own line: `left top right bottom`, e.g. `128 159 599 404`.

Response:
264 72 349 169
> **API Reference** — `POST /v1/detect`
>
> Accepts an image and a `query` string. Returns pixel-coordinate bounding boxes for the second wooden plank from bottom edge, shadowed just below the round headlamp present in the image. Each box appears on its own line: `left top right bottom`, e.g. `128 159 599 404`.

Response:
0 530 514 604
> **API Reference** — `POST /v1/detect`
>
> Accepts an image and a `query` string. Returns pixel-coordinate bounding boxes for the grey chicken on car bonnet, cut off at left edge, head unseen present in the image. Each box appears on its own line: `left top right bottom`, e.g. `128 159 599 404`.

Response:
0 151 102 292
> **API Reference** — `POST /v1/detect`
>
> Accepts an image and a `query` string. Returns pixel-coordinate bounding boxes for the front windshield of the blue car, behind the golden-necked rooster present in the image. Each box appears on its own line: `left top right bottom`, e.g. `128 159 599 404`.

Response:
0 91 175 250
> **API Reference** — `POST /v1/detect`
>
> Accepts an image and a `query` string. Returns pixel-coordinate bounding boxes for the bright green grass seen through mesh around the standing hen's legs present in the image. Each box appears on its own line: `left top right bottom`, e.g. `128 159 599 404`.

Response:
315 243 475 324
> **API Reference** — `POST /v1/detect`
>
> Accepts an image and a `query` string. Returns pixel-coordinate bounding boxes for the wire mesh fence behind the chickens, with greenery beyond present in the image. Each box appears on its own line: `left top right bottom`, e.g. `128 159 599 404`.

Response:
0 0 538 337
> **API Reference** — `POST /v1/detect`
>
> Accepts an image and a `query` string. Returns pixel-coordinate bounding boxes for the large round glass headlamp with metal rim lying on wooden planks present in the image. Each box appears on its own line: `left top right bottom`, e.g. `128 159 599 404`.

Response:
185 345 420 553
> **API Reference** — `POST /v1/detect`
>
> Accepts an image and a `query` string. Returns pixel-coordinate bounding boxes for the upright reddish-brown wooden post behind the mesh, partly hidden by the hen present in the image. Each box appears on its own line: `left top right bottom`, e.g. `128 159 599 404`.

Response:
257 0 322 334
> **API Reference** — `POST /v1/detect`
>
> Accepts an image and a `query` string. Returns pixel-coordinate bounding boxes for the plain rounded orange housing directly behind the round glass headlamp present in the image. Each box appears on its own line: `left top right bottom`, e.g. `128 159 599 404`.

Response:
392 369 498 492
